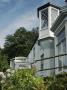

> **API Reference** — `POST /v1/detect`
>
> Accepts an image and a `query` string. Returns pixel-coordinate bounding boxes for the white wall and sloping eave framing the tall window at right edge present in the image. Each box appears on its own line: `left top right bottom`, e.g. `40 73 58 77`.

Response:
54 19 67 74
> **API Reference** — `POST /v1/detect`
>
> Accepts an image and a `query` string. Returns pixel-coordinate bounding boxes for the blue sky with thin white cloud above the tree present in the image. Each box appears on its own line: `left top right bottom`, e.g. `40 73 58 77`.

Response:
0 0 64 48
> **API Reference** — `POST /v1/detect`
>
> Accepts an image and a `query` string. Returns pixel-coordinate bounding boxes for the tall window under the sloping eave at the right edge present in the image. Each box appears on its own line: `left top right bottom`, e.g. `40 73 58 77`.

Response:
57 28 66 71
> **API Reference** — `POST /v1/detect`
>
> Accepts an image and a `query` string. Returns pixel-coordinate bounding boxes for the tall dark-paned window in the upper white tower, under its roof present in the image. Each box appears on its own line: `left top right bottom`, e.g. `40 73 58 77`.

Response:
41 9 48 29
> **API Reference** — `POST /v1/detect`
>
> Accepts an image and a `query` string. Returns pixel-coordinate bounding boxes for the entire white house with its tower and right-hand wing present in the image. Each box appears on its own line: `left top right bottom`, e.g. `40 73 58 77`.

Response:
27 3 67 76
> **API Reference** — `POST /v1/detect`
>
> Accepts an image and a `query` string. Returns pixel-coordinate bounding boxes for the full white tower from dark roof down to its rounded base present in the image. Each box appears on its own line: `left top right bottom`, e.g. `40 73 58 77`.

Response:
37 3 59 76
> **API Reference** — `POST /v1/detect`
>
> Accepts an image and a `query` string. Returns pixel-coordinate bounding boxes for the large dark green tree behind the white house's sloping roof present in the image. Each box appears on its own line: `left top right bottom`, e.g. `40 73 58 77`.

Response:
4 27 38 58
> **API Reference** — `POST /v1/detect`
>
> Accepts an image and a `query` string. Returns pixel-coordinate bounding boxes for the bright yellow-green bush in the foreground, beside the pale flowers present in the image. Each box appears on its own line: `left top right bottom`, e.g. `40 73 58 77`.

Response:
3 69 45 90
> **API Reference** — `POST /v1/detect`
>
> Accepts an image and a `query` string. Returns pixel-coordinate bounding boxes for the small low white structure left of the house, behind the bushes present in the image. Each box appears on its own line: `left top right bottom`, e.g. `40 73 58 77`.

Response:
10 57 31 69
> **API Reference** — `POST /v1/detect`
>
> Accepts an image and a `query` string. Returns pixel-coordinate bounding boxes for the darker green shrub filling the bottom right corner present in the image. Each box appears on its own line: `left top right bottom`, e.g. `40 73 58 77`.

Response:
45 73 67 90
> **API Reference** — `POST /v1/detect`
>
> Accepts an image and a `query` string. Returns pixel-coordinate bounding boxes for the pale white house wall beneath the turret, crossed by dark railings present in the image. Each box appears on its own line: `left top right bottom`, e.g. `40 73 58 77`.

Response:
27 39 54 76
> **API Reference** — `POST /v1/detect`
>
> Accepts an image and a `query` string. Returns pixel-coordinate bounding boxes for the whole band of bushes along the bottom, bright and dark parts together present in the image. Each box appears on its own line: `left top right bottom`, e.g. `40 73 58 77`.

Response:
2 69 67 90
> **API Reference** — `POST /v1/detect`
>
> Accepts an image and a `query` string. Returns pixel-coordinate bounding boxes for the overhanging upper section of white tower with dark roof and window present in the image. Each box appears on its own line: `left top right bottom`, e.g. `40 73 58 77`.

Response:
37 2 60 39
